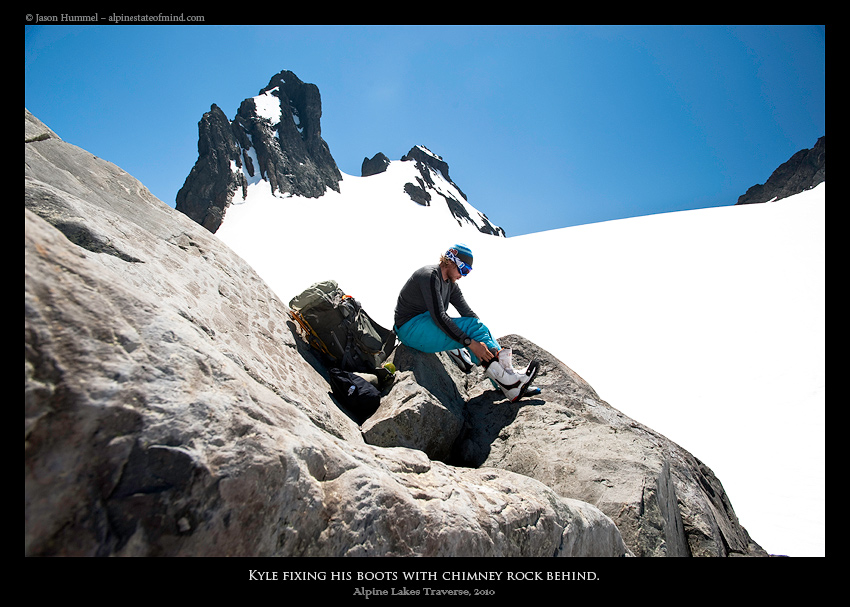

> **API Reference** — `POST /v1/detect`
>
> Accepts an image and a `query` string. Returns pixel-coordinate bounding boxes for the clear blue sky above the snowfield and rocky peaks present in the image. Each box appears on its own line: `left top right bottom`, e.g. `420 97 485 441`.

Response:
25 25 826 236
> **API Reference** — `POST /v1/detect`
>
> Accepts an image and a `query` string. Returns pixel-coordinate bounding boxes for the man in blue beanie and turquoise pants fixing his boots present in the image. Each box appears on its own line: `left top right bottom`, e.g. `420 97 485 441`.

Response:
393 244 539 402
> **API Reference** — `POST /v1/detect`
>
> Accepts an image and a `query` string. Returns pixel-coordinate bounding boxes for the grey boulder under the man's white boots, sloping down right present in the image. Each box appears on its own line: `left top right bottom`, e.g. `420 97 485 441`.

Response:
456 335 767 556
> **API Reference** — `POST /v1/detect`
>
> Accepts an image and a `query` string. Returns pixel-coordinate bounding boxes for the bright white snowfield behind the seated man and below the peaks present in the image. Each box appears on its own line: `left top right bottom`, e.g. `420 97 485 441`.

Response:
217 162 826 556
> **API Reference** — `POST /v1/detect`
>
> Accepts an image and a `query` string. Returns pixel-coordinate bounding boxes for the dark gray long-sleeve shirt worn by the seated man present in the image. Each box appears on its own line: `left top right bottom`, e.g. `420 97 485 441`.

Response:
395 265 478 343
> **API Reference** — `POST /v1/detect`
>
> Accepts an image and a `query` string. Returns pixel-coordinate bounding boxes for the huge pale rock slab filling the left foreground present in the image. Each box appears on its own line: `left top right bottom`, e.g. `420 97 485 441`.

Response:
24 114 628 556
